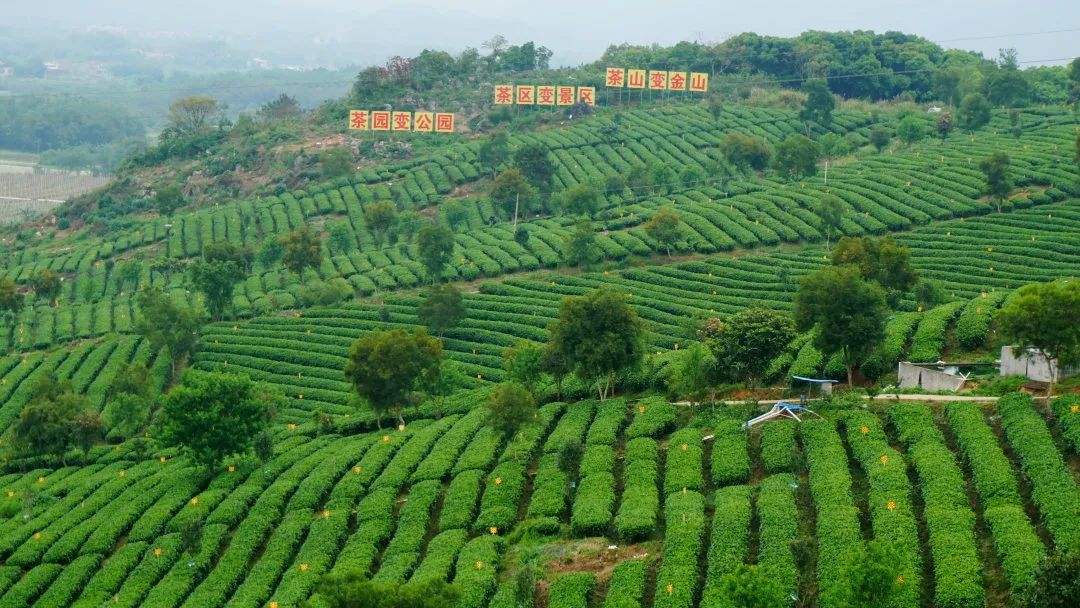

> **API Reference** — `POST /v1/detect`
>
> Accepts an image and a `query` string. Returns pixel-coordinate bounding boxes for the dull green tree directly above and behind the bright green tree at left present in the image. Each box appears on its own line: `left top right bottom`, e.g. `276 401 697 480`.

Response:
135 288 203 379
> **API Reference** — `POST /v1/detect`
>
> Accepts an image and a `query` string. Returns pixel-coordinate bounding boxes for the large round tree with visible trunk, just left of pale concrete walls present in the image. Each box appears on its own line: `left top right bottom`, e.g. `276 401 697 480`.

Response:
795 265 889 386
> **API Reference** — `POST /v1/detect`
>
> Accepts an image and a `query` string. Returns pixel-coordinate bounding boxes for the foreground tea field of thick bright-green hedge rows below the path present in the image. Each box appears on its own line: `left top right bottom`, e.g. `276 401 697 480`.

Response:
0 395 1080 608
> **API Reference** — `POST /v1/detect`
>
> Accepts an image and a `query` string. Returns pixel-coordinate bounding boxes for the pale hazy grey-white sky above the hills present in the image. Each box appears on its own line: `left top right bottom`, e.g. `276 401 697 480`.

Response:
6 0 1080 65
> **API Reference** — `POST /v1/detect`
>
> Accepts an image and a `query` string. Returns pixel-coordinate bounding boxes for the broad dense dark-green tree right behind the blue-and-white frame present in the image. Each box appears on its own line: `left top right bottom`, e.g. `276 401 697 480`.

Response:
700 307 795 389
